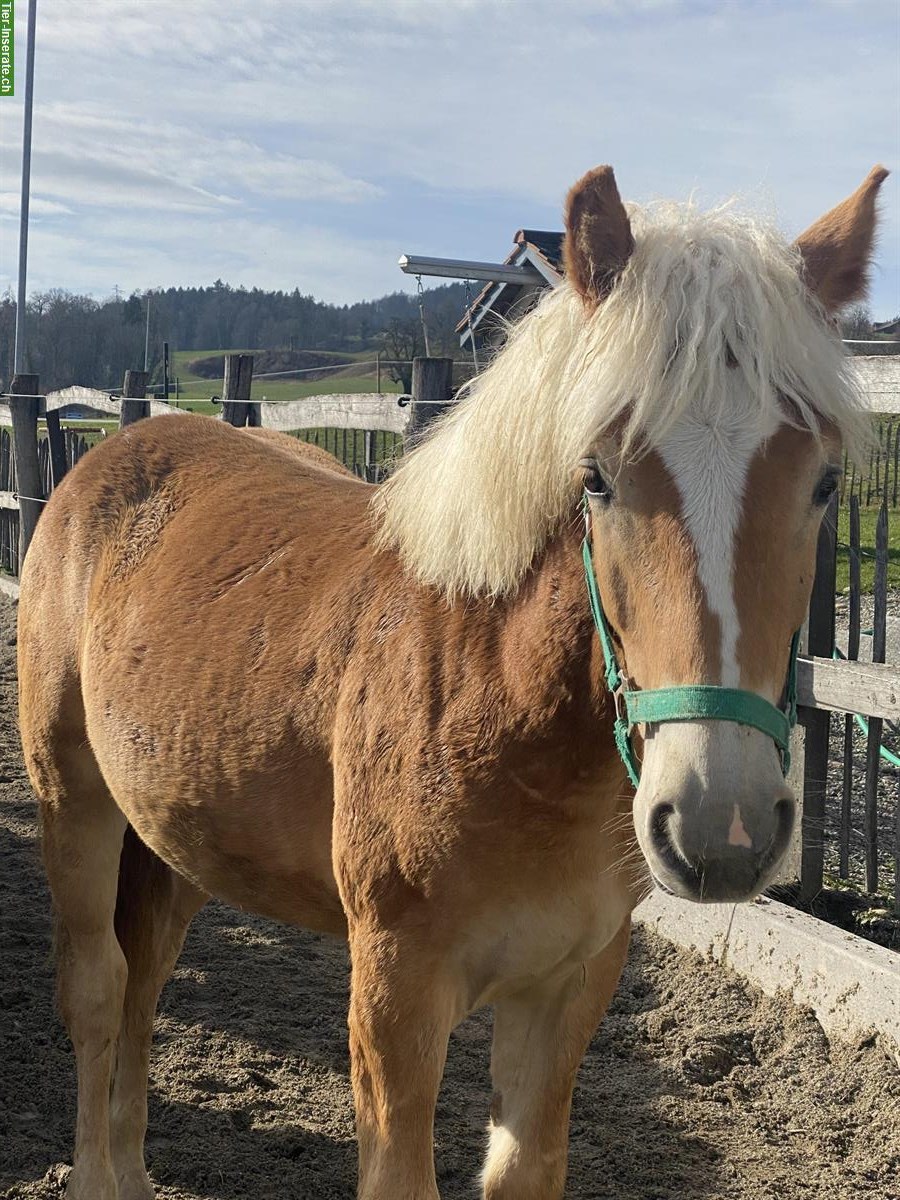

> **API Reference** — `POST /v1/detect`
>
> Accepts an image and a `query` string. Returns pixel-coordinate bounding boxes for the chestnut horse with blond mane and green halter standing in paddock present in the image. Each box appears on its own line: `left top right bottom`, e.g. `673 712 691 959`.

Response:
18 167 887 1200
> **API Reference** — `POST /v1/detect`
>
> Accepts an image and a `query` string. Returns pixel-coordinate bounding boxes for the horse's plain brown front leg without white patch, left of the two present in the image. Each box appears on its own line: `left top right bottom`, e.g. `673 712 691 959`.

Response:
349 923 458 1200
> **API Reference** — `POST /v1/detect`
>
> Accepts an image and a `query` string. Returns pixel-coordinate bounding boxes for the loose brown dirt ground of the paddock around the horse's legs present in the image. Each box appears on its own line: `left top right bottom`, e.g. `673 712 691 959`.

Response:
0 596 900 1200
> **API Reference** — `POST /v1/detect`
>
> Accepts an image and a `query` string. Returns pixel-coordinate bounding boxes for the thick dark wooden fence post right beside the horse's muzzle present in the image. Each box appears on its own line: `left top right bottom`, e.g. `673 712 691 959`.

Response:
800 494 838 900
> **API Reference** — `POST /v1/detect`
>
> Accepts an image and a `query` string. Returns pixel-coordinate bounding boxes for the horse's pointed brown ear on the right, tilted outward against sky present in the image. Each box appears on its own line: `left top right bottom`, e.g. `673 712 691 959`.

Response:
796 167 888 312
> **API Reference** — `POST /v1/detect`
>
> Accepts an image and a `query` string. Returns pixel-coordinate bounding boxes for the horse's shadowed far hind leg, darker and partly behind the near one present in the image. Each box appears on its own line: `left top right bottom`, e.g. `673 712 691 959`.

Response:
109 828 206 1200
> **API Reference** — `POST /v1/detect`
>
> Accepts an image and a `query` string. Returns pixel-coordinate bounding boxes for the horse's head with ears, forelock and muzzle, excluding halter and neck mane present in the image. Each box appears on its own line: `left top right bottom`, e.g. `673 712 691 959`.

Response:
566 167 887 900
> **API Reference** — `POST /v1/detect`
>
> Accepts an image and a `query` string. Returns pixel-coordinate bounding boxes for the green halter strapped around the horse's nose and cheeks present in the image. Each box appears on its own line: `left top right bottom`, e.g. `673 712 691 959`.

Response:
581 502 800 787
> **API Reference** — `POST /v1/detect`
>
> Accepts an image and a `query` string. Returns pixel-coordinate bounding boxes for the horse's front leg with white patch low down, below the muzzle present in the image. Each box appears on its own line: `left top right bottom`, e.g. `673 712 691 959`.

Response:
482 919 631 1200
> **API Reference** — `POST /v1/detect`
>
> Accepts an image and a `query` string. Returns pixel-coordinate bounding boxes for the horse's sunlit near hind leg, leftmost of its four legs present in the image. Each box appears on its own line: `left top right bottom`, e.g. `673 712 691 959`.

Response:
36 748 126 1200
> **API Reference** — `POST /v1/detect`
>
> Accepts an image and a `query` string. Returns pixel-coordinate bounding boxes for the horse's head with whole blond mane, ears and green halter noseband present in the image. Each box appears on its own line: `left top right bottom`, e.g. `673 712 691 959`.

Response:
376 167 887 900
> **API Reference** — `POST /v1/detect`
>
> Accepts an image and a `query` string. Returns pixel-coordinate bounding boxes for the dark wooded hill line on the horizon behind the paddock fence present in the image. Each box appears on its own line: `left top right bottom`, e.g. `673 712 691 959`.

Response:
0 280 475 391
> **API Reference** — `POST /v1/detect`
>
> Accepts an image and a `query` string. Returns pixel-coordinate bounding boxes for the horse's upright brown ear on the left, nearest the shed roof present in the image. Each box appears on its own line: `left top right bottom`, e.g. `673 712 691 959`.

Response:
563 167 635 302
